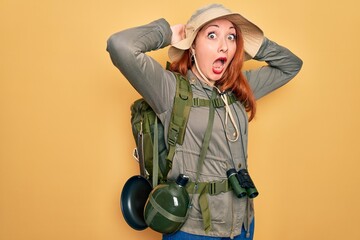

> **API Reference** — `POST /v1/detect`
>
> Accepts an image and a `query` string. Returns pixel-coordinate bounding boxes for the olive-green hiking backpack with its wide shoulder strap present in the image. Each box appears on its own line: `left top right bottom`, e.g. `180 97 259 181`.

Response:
130 73 193 187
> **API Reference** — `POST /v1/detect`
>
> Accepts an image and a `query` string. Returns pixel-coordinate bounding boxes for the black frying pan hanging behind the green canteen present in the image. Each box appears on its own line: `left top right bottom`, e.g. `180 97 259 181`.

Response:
120 175 152 230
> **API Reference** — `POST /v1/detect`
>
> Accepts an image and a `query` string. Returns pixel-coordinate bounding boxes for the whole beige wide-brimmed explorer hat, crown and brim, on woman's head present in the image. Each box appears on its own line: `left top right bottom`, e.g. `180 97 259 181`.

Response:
168 4 264 61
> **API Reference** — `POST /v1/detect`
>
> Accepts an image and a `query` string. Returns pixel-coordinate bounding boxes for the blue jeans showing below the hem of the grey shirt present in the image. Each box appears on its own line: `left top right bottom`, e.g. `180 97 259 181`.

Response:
162 221 255 240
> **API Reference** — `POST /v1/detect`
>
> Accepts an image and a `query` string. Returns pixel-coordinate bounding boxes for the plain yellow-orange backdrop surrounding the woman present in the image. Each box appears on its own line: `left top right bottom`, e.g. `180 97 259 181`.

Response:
0 0 360 240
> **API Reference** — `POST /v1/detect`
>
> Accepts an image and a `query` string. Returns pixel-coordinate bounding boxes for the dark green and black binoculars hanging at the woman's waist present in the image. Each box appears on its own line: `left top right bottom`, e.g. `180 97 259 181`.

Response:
226 168 259 198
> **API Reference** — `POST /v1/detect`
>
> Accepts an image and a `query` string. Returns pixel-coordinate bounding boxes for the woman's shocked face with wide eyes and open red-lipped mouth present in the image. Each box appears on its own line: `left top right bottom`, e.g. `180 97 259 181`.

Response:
192 19 236 84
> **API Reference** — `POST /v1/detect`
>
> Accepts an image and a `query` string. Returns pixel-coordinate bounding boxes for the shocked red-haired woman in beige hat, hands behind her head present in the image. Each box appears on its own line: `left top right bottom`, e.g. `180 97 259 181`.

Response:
107 4 302 240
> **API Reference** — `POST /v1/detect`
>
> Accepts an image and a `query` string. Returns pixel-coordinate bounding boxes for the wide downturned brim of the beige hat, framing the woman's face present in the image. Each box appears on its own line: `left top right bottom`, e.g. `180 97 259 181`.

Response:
168 13 264 61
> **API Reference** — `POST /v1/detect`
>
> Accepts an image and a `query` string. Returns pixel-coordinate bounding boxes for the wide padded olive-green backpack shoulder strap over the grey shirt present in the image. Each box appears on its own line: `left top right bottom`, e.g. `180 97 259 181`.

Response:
166 73 193 169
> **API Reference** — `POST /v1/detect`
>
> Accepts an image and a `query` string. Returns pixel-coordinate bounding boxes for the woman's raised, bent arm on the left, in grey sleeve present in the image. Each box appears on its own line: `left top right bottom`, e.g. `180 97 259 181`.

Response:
107 19 175 113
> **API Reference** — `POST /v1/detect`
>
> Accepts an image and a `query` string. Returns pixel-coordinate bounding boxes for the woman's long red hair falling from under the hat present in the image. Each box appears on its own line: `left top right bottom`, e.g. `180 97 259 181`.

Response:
170 24 256 121
